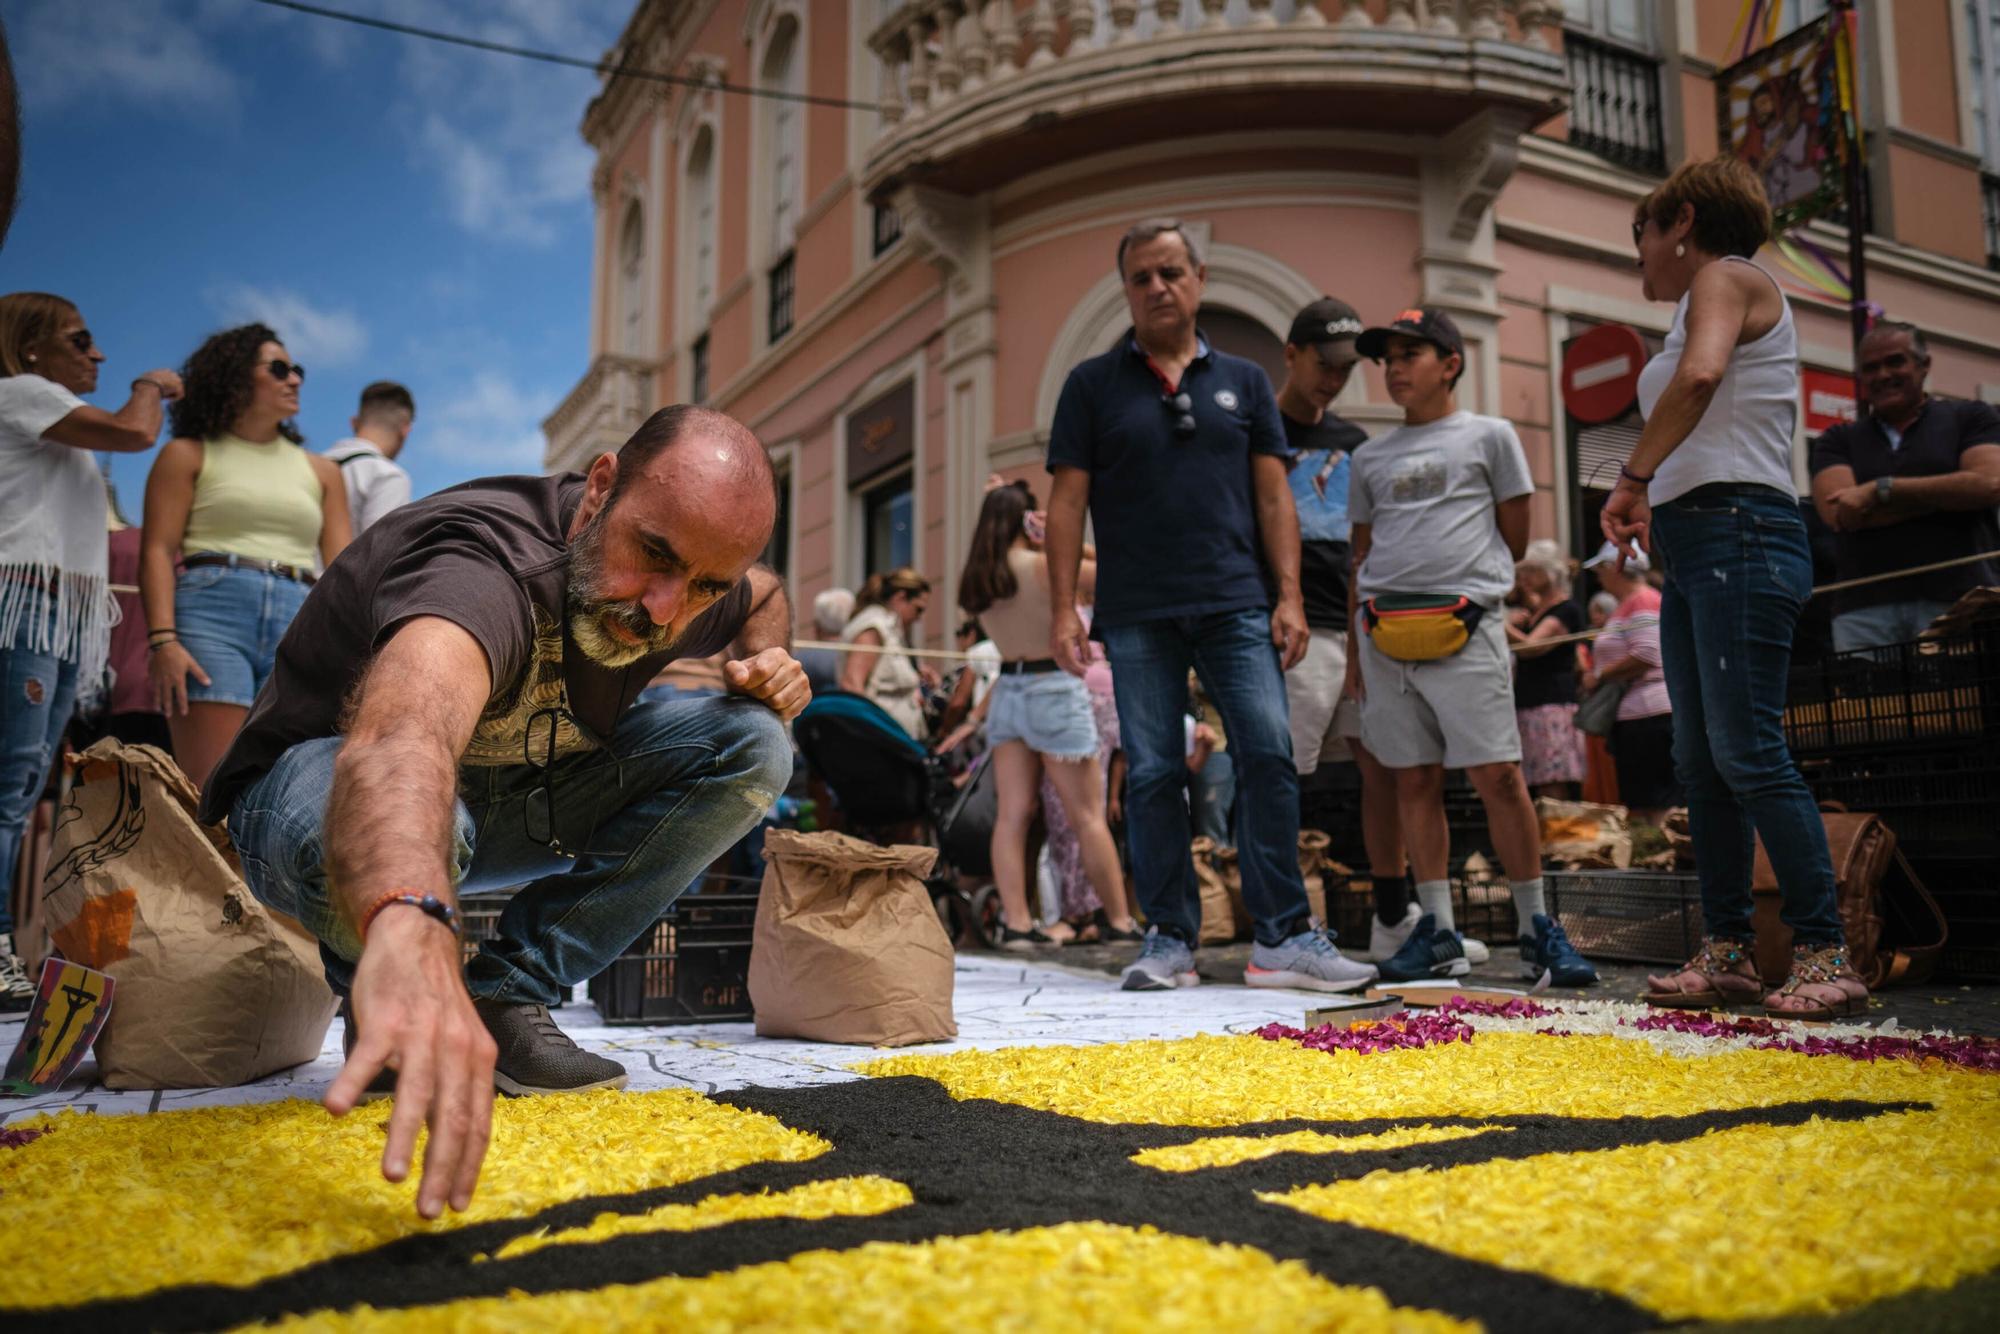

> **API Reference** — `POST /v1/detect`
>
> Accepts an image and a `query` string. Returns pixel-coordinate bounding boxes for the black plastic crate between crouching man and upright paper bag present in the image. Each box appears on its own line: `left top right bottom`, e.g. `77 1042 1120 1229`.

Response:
590 892 758 1024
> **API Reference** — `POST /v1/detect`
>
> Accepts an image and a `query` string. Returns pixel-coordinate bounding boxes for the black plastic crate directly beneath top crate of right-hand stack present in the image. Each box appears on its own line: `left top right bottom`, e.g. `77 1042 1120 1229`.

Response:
1800 744 2000 860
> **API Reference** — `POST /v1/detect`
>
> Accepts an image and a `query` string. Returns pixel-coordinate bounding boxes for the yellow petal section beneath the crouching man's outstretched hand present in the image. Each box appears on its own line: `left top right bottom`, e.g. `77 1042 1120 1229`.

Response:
0 1090 830 1306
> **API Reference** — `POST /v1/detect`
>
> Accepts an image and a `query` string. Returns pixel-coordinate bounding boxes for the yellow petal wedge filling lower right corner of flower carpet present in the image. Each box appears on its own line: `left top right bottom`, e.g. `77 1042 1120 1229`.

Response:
1258 1104 2000 1320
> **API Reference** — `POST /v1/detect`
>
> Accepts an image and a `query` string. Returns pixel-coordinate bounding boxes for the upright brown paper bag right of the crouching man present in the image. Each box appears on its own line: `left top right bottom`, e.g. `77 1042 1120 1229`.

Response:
750 830 958 1046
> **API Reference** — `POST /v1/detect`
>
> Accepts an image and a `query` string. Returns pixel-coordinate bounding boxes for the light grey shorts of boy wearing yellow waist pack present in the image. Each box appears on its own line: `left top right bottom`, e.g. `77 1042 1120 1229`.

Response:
1354 608 1520 768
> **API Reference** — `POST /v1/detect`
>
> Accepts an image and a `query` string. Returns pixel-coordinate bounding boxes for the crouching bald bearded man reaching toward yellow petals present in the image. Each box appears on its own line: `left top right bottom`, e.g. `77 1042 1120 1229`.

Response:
202 406 810 1218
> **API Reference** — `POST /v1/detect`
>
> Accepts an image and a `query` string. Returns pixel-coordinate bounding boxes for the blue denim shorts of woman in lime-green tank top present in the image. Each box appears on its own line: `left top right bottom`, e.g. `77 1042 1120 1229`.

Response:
174 566 310 708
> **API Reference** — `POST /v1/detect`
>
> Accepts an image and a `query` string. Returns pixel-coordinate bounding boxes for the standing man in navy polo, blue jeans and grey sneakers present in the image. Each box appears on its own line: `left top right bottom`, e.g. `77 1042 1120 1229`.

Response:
1046 220 1376 990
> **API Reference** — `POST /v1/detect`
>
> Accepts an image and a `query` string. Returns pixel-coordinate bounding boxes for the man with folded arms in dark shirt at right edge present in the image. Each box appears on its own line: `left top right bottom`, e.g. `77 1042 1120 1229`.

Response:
1812 320 2000 652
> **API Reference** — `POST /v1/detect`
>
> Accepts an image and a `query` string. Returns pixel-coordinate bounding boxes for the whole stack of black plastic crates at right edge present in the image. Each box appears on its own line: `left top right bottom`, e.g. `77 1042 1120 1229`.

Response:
1784 618 2000 980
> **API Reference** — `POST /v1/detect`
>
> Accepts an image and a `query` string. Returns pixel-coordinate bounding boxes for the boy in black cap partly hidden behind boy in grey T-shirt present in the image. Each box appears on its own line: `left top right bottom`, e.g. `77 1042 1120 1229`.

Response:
1278 296 1418 964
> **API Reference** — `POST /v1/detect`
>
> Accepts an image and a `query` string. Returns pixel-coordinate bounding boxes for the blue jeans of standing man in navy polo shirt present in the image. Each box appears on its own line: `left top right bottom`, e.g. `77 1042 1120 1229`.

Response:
1100 610 1310 946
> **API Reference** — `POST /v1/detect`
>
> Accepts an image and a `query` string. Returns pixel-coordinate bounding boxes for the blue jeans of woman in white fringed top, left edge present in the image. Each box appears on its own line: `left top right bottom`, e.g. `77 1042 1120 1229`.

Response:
0 594 76 934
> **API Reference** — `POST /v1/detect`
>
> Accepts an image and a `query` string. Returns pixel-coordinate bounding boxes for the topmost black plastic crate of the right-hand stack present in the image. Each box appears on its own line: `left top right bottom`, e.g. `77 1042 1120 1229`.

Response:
1784 620 2000 760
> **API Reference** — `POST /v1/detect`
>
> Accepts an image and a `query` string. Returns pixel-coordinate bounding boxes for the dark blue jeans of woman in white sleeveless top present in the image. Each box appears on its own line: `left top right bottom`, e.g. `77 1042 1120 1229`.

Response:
1652 488 1842 948
